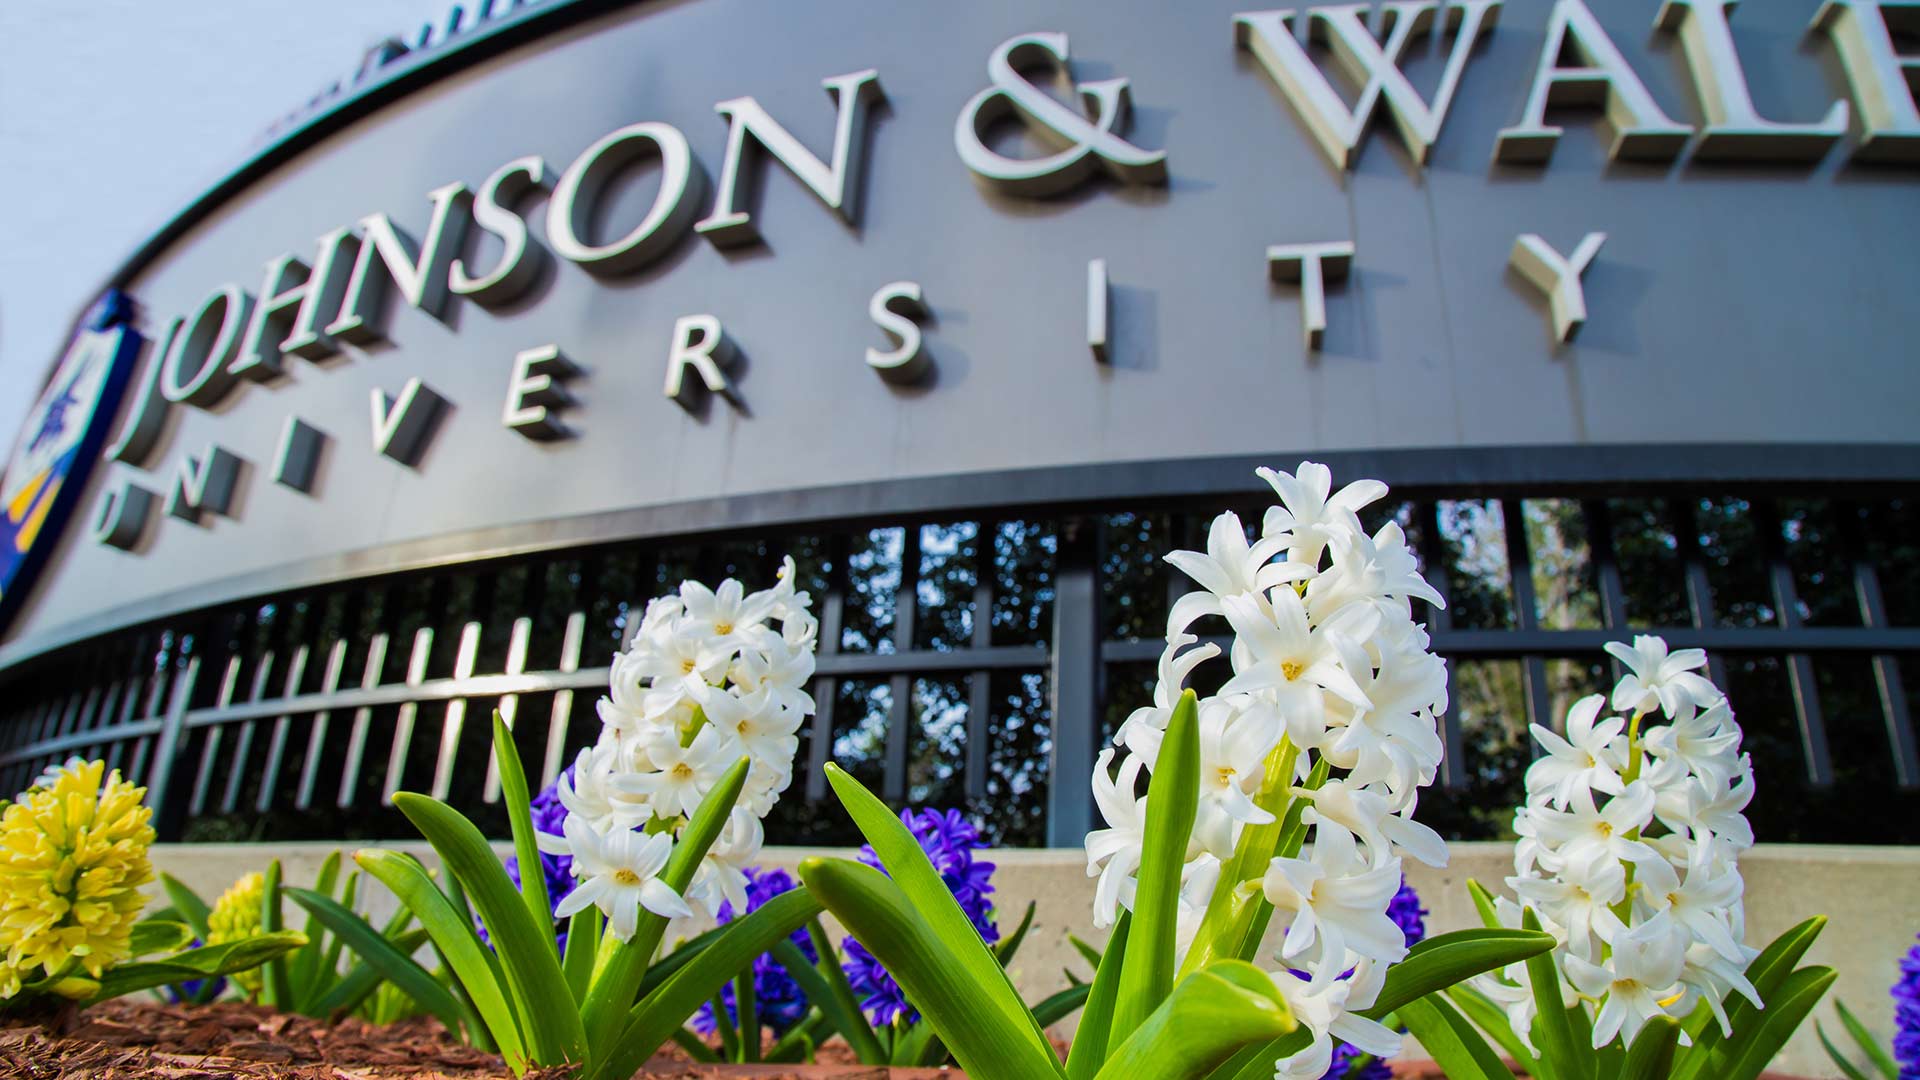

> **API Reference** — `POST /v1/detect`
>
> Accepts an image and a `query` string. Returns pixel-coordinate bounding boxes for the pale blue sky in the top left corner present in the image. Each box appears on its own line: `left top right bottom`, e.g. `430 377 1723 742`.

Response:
0 0 449 446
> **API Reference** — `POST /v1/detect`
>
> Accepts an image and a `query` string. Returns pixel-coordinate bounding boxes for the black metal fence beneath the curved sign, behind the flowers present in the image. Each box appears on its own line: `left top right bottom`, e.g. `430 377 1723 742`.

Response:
0 488 1920 846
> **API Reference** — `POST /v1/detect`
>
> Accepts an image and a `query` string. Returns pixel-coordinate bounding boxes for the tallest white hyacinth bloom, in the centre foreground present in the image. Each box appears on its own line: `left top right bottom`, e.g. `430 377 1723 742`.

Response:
1087 461 1448 1076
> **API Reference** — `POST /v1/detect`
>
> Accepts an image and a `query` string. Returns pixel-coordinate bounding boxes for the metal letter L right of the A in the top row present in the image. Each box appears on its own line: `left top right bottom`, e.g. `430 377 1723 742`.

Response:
1653 0 1847 161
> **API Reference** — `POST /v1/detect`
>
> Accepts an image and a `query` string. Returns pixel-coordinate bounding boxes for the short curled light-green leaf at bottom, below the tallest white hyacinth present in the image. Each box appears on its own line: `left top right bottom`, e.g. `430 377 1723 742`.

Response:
1094 957 1296 1080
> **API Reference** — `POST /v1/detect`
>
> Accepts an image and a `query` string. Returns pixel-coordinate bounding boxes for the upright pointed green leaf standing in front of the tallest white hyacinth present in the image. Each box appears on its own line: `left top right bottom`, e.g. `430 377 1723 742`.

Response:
1108 690 1200 1043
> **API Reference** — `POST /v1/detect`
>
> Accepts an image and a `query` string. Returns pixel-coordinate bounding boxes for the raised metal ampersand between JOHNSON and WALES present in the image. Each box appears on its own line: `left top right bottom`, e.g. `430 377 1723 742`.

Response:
954 33 1167 196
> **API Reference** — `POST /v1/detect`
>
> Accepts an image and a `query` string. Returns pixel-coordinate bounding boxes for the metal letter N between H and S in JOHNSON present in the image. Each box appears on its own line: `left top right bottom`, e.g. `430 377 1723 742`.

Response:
326 181 474 344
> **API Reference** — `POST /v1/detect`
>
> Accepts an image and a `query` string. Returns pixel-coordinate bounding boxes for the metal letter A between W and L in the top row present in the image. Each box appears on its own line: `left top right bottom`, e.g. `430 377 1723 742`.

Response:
1494 0 1693 165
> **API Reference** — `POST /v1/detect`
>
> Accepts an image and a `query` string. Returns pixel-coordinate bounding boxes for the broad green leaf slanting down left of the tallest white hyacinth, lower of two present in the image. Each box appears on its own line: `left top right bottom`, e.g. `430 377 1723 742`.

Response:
794 853 1062 1080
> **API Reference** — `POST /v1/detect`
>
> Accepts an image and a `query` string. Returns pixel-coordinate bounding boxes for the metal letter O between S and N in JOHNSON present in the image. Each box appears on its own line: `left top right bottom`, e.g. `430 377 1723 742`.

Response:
547 121 705 273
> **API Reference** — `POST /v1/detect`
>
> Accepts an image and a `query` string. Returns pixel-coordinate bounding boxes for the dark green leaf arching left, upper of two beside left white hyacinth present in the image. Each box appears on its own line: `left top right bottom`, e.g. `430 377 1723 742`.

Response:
394 792 588 1065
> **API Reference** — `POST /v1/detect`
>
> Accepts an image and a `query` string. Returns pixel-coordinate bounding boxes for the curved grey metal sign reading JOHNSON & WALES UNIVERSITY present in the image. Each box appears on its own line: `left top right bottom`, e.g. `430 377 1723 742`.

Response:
6 0 1920 657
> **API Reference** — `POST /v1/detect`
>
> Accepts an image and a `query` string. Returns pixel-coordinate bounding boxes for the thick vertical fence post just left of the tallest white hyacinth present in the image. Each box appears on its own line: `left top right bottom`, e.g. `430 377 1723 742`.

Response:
1046 517 1100 847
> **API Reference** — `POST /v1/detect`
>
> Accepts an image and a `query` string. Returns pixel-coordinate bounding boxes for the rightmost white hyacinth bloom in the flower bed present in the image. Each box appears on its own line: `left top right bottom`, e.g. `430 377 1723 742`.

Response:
1475 634 1759 1047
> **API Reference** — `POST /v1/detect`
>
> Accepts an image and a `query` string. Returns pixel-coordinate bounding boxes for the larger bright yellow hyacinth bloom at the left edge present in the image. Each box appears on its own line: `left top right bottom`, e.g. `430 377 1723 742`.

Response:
0 749 154 999
